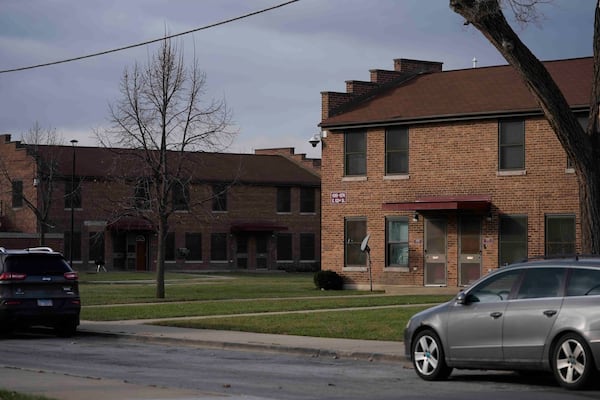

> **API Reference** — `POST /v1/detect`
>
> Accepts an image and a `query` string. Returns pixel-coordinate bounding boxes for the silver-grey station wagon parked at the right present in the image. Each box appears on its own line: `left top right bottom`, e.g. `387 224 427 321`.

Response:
404 257 600 389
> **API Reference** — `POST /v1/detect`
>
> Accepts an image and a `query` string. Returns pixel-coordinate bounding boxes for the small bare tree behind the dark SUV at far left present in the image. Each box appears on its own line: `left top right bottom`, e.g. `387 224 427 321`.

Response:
0 121 63 245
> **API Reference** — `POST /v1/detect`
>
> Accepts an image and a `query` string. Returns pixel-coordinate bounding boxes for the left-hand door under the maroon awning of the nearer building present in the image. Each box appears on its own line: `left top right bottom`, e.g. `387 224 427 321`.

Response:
425 219 447 286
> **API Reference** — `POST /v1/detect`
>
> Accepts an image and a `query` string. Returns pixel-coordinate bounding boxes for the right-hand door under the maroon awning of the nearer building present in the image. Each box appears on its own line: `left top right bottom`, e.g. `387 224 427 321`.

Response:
458 216 481 286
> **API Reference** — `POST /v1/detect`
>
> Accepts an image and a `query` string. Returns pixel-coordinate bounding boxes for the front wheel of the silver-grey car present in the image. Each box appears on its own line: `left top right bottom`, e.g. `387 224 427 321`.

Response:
412 329 452 381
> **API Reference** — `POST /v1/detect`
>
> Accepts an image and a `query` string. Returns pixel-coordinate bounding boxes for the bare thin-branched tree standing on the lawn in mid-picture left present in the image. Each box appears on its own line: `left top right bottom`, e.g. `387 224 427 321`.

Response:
99 39 234 298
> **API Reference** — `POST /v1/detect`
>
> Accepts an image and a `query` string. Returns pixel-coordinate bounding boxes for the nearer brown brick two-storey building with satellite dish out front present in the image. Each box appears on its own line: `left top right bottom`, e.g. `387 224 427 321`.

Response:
320 58 593 288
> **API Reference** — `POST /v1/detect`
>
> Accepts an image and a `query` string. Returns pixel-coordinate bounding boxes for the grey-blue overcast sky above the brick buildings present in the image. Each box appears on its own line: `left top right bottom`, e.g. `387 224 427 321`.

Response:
0 0 596 157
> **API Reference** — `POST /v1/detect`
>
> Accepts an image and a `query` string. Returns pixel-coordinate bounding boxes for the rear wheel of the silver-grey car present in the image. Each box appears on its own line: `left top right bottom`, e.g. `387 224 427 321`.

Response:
552 333 594 389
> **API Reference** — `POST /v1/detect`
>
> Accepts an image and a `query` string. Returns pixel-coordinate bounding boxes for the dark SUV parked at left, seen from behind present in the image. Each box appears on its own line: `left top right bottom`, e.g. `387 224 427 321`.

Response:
0 247 81 336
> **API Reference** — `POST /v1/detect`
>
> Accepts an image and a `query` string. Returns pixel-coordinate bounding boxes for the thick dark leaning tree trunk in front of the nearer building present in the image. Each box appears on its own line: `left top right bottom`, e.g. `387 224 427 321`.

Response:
450 0 600 254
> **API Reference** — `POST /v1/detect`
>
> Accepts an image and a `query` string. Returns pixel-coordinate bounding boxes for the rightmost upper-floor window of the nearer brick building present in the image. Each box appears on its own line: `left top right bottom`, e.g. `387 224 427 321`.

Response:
498 120 525 170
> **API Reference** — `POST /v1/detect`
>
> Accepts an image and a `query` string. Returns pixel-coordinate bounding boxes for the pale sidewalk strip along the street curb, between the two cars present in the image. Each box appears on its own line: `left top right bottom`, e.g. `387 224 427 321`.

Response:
78 321 407 362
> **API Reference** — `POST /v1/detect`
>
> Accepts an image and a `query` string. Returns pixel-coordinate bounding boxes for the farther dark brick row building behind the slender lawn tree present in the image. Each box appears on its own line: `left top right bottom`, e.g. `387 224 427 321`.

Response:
0 135 320 271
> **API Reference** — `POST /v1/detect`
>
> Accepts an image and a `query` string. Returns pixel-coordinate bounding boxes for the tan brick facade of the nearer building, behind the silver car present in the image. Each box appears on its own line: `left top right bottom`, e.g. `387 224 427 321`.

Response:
321 56 586 289
